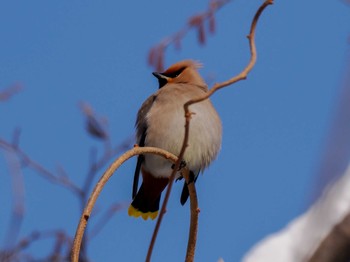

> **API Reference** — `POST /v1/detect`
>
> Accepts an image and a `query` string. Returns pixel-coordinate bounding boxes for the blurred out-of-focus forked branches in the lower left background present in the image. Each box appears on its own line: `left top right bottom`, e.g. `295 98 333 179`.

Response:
0 103 133 262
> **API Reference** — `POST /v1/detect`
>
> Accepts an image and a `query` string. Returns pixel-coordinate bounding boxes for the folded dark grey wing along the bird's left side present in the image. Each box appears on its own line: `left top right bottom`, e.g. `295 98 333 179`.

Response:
132 95 157 199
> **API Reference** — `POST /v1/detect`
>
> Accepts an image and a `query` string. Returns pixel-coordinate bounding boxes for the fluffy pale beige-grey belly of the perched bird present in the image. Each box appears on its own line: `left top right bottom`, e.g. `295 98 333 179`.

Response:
144 100 221 177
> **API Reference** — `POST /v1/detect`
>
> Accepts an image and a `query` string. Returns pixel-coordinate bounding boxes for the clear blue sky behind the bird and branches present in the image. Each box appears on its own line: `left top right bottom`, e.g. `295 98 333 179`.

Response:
0 0 350 261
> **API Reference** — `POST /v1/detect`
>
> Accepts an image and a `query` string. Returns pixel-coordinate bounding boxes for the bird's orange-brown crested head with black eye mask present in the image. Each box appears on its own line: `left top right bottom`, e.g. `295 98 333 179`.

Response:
153 60 207 89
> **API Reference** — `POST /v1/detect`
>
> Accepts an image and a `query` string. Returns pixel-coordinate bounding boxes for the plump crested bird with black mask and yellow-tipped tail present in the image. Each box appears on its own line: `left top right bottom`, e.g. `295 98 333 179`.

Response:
128 60 222 220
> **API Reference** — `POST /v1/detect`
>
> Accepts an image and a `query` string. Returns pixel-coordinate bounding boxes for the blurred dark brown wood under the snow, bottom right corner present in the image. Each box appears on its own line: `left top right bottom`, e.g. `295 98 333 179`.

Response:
308 214 350 262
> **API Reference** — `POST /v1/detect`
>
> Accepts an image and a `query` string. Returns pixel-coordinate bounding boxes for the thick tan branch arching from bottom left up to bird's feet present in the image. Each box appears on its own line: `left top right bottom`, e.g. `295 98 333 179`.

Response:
71 147 177 262
